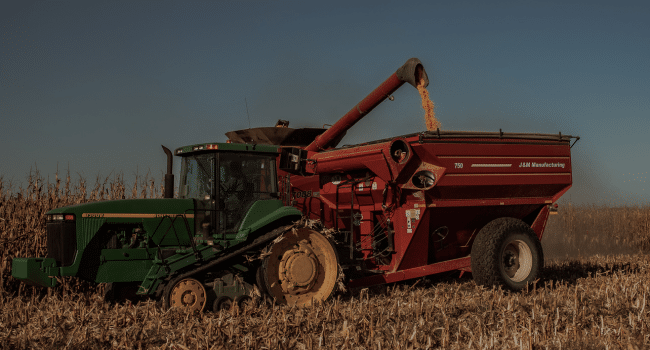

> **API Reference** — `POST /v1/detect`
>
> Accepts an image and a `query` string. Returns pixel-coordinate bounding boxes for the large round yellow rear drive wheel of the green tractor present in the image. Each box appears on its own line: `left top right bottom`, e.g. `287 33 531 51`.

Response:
260 228 339 306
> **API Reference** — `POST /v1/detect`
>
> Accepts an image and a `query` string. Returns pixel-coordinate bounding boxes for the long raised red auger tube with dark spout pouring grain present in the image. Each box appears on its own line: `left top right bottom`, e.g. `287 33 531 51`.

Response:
305 58 429 152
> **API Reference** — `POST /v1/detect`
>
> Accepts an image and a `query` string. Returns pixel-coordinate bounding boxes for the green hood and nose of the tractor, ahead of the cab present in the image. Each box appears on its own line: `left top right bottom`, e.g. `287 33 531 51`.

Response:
12 198 194 287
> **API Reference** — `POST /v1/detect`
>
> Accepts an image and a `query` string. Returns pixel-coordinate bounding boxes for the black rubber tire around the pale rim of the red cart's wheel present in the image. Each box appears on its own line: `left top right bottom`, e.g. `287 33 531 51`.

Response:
471 217 544 289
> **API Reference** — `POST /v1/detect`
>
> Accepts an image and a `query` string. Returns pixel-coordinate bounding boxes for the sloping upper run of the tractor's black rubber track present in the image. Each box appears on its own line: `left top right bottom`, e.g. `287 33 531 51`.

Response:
155 225 295 300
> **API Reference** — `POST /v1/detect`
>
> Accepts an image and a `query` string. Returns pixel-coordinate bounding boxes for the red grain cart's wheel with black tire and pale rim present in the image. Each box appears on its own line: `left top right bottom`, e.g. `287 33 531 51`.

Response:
471 218 544 290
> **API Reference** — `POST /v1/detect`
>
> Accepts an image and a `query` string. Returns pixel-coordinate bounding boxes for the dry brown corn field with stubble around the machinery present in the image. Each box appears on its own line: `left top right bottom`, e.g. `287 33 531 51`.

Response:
0 173 650 349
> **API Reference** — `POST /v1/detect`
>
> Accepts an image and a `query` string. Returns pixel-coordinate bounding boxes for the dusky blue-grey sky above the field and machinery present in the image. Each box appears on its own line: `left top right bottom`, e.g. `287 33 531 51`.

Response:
0 0 650 203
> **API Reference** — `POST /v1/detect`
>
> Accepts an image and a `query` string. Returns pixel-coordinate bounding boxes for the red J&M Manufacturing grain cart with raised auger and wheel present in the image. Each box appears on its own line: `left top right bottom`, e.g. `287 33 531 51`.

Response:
231 59 579 299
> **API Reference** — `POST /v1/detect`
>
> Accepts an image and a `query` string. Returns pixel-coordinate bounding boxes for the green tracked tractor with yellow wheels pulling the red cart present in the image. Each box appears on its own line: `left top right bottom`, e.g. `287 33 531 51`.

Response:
12 143 338 311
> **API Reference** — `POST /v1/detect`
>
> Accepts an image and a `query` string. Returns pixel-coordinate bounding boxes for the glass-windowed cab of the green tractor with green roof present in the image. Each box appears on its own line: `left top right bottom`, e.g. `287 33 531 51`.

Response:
175 143 280 239
